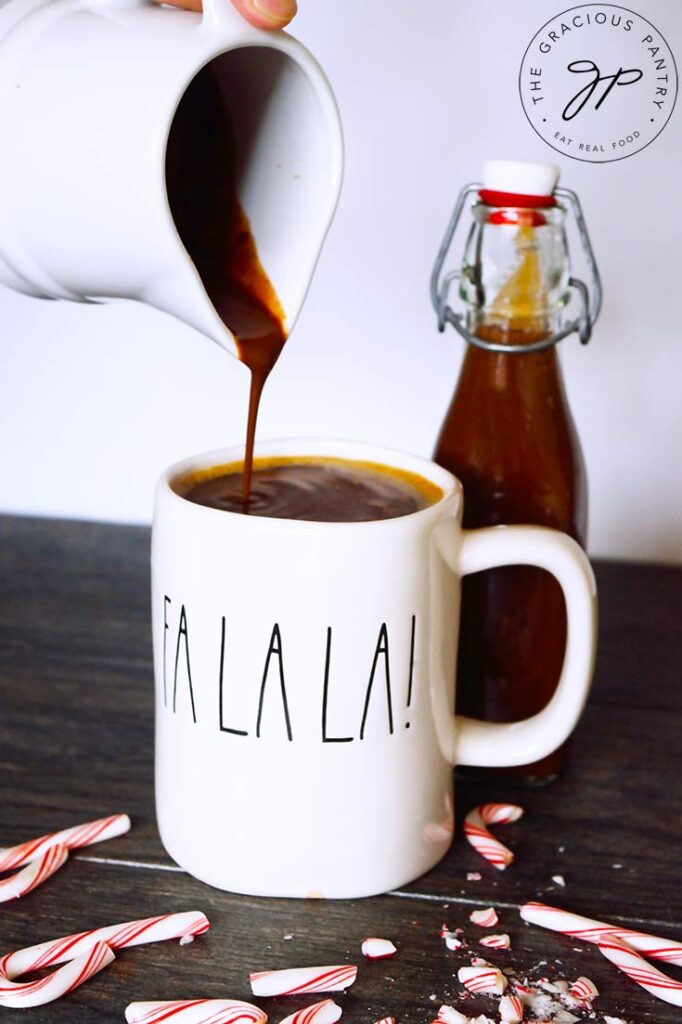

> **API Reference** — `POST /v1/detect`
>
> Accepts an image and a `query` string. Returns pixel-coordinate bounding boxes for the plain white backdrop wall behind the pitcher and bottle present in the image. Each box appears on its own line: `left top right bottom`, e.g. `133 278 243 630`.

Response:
0 0 682 561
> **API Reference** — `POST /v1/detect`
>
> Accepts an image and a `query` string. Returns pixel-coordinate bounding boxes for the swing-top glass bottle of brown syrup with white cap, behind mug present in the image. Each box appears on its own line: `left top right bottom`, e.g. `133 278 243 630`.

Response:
434 161 598 781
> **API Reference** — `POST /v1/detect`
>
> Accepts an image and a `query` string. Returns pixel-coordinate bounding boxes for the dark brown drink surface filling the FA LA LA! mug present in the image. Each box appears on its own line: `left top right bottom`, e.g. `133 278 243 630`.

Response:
173 457 442 522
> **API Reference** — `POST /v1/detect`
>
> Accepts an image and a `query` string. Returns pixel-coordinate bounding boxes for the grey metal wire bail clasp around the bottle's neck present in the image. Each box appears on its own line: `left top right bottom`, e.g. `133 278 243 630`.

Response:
430 182 602 355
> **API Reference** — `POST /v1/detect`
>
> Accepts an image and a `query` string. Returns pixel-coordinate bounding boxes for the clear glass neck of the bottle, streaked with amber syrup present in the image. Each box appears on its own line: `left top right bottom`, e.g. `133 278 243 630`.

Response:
461 203 569 346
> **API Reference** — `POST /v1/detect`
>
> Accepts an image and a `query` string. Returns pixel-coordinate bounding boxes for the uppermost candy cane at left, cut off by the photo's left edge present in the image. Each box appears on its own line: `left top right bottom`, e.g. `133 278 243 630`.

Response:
0 814 130 903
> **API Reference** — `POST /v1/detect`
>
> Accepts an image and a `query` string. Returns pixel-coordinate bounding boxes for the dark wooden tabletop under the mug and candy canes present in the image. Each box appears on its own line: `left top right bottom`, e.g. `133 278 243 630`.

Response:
0 517 682 1024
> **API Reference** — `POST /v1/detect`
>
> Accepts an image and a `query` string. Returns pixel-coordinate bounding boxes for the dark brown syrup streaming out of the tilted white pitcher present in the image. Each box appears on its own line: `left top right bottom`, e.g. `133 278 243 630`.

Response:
166 57 287 503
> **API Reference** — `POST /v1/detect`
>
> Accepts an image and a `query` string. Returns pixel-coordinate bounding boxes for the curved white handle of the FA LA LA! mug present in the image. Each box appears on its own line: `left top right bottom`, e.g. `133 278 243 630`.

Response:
438 526 597 768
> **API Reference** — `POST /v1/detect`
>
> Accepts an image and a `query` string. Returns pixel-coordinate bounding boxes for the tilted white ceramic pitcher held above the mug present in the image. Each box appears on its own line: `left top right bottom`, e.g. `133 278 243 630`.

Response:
0 0 342 351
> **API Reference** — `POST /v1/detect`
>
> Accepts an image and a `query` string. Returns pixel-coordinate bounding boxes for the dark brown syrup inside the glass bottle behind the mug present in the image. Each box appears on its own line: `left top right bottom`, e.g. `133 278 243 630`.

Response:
435 327 587 778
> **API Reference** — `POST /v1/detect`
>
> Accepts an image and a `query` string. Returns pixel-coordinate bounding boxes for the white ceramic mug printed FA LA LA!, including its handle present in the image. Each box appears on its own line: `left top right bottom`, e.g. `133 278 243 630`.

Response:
152 440 596 897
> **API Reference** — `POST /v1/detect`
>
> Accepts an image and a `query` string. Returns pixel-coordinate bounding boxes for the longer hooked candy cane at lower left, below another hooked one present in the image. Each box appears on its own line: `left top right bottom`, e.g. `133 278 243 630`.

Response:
0 911 210 1008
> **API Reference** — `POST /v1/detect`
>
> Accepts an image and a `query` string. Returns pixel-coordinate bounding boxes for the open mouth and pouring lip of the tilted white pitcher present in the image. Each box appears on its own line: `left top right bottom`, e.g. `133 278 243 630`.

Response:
157 36 341 350
